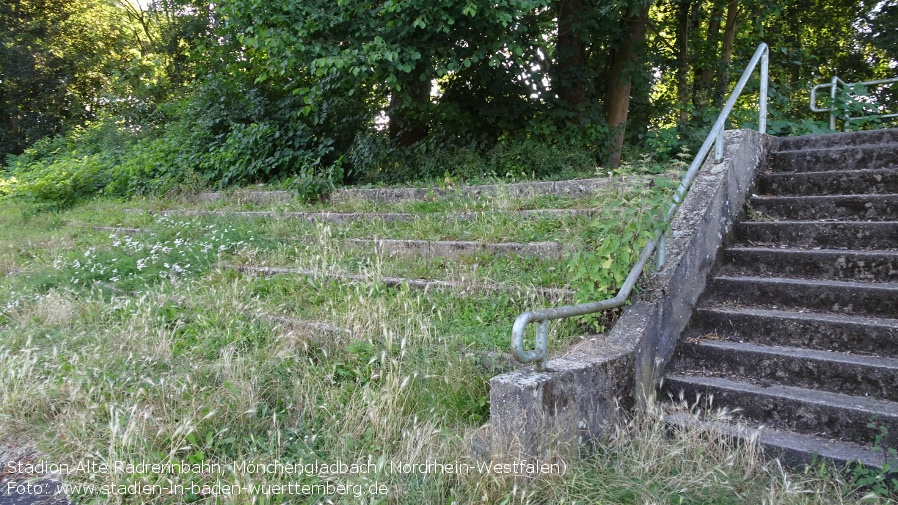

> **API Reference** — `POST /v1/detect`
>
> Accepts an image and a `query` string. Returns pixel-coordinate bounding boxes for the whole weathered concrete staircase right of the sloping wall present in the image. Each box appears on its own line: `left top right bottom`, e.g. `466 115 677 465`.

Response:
662 129 898 468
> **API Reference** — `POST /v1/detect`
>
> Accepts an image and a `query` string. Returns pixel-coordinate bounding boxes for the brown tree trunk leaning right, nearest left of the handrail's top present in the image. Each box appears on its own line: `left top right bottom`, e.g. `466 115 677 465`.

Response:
605 5 649 168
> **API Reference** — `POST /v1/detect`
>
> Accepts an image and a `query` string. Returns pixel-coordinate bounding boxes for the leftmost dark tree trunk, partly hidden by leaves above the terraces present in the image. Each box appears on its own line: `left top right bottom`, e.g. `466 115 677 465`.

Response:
389 57 430 147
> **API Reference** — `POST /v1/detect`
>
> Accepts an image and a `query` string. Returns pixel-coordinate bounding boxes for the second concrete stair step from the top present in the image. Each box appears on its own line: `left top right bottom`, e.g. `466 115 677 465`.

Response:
768 143 898 172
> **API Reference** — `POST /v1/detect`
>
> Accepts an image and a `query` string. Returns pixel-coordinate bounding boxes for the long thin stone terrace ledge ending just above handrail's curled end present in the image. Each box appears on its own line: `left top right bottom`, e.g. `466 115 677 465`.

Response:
226 265 575 303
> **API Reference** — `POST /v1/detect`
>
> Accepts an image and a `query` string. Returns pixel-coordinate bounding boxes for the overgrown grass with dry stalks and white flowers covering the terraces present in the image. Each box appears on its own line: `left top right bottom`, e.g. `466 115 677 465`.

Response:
0 187 880 504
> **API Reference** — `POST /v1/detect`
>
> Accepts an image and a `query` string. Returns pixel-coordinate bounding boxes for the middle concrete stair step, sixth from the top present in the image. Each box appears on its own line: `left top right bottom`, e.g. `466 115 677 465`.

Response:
718 247 898 282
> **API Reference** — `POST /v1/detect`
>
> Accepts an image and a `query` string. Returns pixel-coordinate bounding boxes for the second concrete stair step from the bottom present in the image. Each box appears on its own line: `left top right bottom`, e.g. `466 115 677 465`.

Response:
663 374 898 447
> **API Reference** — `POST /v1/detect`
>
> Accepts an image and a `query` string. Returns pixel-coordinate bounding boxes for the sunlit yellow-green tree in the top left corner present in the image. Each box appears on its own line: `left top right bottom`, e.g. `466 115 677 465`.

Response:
0 0 129 158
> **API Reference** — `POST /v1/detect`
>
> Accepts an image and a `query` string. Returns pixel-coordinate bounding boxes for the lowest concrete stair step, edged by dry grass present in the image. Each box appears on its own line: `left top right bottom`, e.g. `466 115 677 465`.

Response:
664 413 898 471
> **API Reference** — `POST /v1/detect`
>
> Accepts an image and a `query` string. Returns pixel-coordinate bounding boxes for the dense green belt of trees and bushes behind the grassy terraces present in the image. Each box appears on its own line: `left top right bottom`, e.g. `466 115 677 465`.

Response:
0 0 898 201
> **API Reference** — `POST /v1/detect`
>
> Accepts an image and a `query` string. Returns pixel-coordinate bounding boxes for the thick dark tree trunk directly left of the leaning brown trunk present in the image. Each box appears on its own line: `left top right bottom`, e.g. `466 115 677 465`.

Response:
552 0 589 120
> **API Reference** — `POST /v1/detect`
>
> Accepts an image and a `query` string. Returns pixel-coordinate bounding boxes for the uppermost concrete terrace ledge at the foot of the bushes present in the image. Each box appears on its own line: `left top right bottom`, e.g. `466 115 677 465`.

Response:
198 176 651 205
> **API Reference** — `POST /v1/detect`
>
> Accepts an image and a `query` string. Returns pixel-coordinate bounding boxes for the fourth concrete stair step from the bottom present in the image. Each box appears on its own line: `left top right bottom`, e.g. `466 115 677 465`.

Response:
684 304 898 358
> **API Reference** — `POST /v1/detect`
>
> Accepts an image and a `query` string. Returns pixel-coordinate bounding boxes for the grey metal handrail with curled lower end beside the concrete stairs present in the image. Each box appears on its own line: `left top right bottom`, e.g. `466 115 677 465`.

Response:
511 42 770 372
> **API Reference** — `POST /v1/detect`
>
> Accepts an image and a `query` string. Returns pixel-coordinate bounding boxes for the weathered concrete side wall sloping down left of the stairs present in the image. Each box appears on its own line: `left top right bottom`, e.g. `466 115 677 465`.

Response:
490 131 771 456
